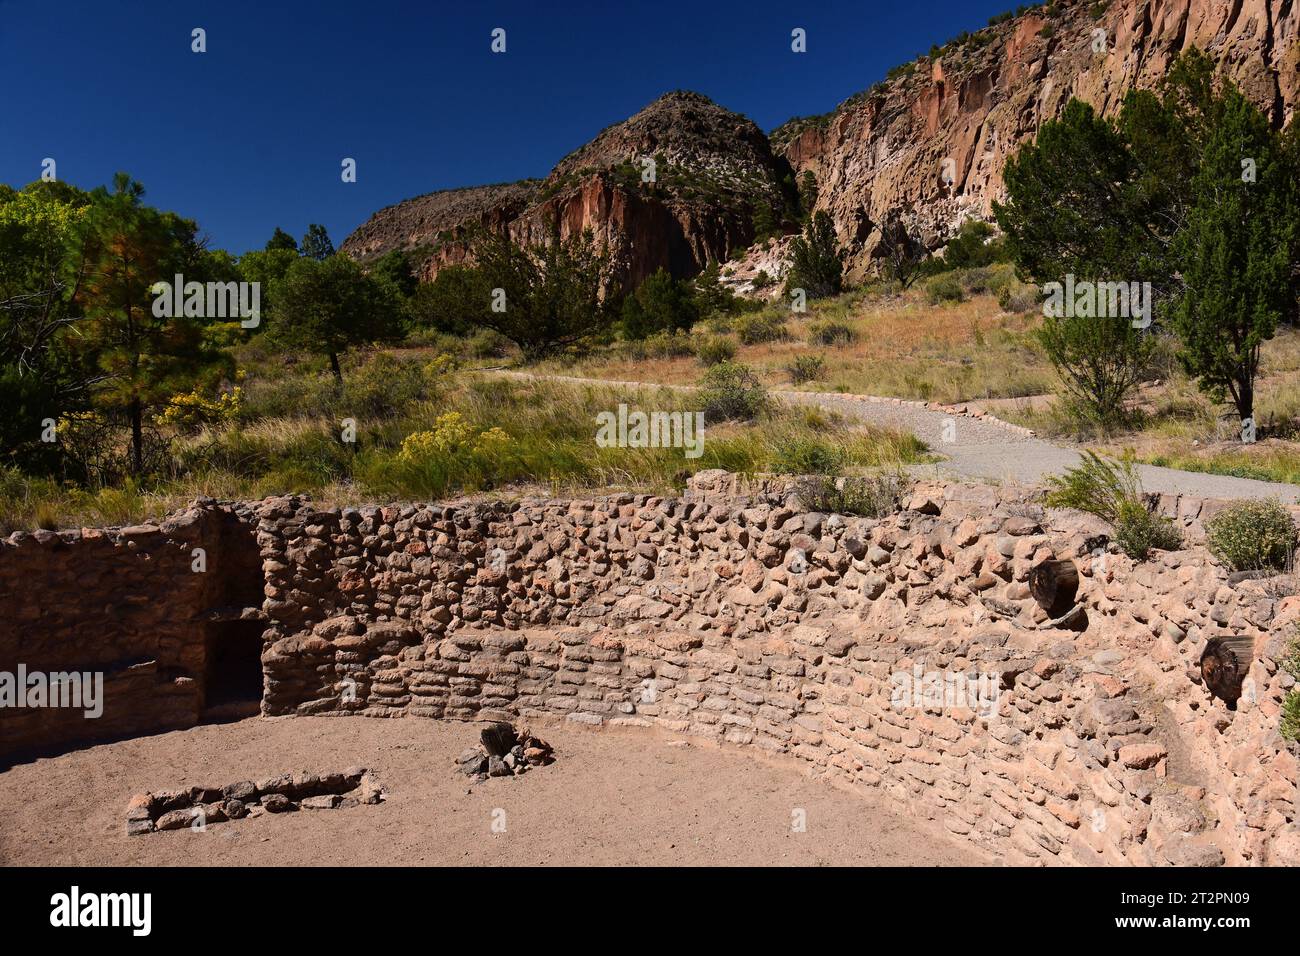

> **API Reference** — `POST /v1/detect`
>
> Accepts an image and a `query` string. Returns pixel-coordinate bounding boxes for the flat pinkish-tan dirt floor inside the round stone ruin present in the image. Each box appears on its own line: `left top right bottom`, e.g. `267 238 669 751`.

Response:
0 717 993 866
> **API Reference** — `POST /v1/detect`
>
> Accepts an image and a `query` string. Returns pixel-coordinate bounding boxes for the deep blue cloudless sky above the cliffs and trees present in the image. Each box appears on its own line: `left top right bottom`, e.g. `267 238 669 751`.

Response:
0 0 1015 254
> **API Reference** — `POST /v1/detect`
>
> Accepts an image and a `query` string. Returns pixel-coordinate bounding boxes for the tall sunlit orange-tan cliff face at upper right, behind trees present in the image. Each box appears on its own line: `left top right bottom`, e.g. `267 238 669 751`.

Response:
772 0 1300 277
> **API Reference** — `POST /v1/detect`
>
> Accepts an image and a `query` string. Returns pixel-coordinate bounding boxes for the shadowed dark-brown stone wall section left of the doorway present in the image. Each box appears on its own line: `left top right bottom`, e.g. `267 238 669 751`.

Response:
0 502 261 758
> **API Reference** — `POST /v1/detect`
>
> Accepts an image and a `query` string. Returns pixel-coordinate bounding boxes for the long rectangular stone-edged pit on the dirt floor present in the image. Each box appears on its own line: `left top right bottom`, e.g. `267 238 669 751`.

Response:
126 767 386 836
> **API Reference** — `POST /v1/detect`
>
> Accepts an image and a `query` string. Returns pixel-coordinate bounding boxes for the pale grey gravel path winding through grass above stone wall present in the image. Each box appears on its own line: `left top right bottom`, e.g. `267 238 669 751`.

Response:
493 371 1300 503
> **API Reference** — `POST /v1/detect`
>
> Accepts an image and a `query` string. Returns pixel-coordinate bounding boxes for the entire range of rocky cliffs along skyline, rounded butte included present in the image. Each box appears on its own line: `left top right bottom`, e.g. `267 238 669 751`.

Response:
343 0 1300 285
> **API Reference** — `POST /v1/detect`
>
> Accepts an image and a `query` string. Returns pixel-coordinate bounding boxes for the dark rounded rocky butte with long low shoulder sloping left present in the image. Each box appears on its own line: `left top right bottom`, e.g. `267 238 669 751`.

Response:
343 91 789 285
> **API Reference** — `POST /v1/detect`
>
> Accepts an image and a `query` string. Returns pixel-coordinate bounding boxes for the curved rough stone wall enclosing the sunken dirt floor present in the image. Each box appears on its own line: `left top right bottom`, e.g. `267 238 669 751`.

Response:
0 472 1300 865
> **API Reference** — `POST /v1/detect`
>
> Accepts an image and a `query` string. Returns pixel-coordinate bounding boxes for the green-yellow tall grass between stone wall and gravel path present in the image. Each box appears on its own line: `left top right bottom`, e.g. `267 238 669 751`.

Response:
0 356 928 532
